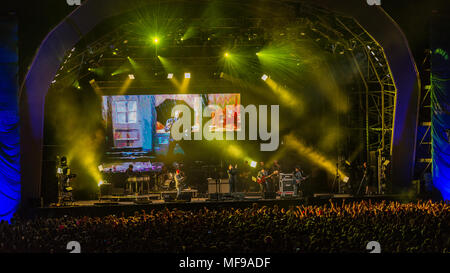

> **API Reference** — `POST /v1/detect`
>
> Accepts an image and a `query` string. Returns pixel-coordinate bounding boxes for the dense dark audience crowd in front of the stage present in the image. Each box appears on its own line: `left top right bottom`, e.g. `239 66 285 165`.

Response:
0 201 450 253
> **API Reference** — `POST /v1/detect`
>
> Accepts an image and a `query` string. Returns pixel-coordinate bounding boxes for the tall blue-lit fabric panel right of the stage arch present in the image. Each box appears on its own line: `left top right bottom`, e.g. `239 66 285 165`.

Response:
431 16 450 200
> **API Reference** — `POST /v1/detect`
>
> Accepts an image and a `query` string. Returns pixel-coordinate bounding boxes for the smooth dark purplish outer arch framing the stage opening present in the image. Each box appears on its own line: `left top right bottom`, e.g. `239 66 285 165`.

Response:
19 0 420 206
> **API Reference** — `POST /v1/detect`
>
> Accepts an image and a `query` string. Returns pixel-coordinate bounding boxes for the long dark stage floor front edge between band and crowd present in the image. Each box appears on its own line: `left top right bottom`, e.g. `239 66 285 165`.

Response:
27 193 417 217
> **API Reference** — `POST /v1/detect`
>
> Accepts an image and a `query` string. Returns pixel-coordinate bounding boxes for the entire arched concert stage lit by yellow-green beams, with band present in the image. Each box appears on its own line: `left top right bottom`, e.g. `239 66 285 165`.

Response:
9 0 428 223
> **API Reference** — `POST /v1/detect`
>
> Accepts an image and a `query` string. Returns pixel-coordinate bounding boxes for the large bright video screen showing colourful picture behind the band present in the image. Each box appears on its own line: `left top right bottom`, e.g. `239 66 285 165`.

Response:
102 93 241 158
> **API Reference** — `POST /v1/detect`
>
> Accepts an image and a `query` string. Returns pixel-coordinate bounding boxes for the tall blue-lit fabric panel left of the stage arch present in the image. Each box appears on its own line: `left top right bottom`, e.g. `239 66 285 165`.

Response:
0 17 20 220
